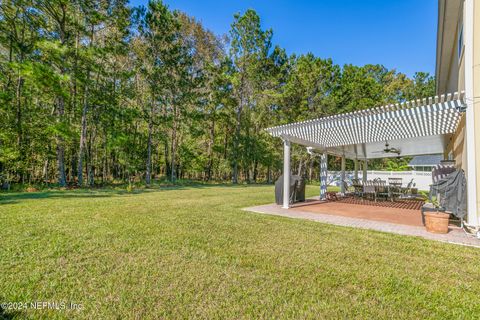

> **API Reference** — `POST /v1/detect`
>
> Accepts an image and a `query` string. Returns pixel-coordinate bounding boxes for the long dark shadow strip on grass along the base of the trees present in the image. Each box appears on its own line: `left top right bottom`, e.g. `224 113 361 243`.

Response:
0 183 271 205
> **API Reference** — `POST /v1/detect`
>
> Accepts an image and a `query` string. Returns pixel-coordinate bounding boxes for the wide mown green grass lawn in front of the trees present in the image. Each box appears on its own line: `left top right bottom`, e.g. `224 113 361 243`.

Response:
0 185 480 319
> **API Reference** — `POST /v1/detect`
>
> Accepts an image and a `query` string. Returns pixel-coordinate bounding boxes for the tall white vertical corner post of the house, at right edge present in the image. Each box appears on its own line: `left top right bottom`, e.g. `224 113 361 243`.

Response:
463 0 479 227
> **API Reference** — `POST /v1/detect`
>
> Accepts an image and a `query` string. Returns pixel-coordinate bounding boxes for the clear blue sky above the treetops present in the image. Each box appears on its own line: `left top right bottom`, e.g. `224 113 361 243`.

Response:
131 0 437 76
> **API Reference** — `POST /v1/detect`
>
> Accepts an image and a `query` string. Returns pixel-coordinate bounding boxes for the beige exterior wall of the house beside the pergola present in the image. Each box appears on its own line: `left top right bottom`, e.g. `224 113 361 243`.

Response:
437 0 480 225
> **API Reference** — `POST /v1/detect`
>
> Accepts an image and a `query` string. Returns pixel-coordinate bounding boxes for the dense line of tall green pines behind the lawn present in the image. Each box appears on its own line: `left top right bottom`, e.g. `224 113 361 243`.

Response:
0 0 434 186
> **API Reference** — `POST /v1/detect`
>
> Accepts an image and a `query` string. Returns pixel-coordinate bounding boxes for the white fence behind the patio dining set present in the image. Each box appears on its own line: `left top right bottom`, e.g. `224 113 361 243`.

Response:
327 171 432 190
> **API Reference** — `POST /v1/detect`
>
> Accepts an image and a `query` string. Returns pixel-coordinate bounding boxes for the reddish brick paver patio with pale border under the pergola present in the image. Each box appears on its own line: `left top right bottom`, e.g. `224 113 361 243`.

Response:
244 201 480 248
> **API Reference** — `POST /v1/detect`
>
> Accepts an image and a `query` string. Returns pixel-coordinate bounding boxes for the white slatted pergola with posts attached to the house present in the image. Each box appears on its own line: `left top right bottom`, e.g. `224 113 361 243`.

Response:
267 92 466 208
